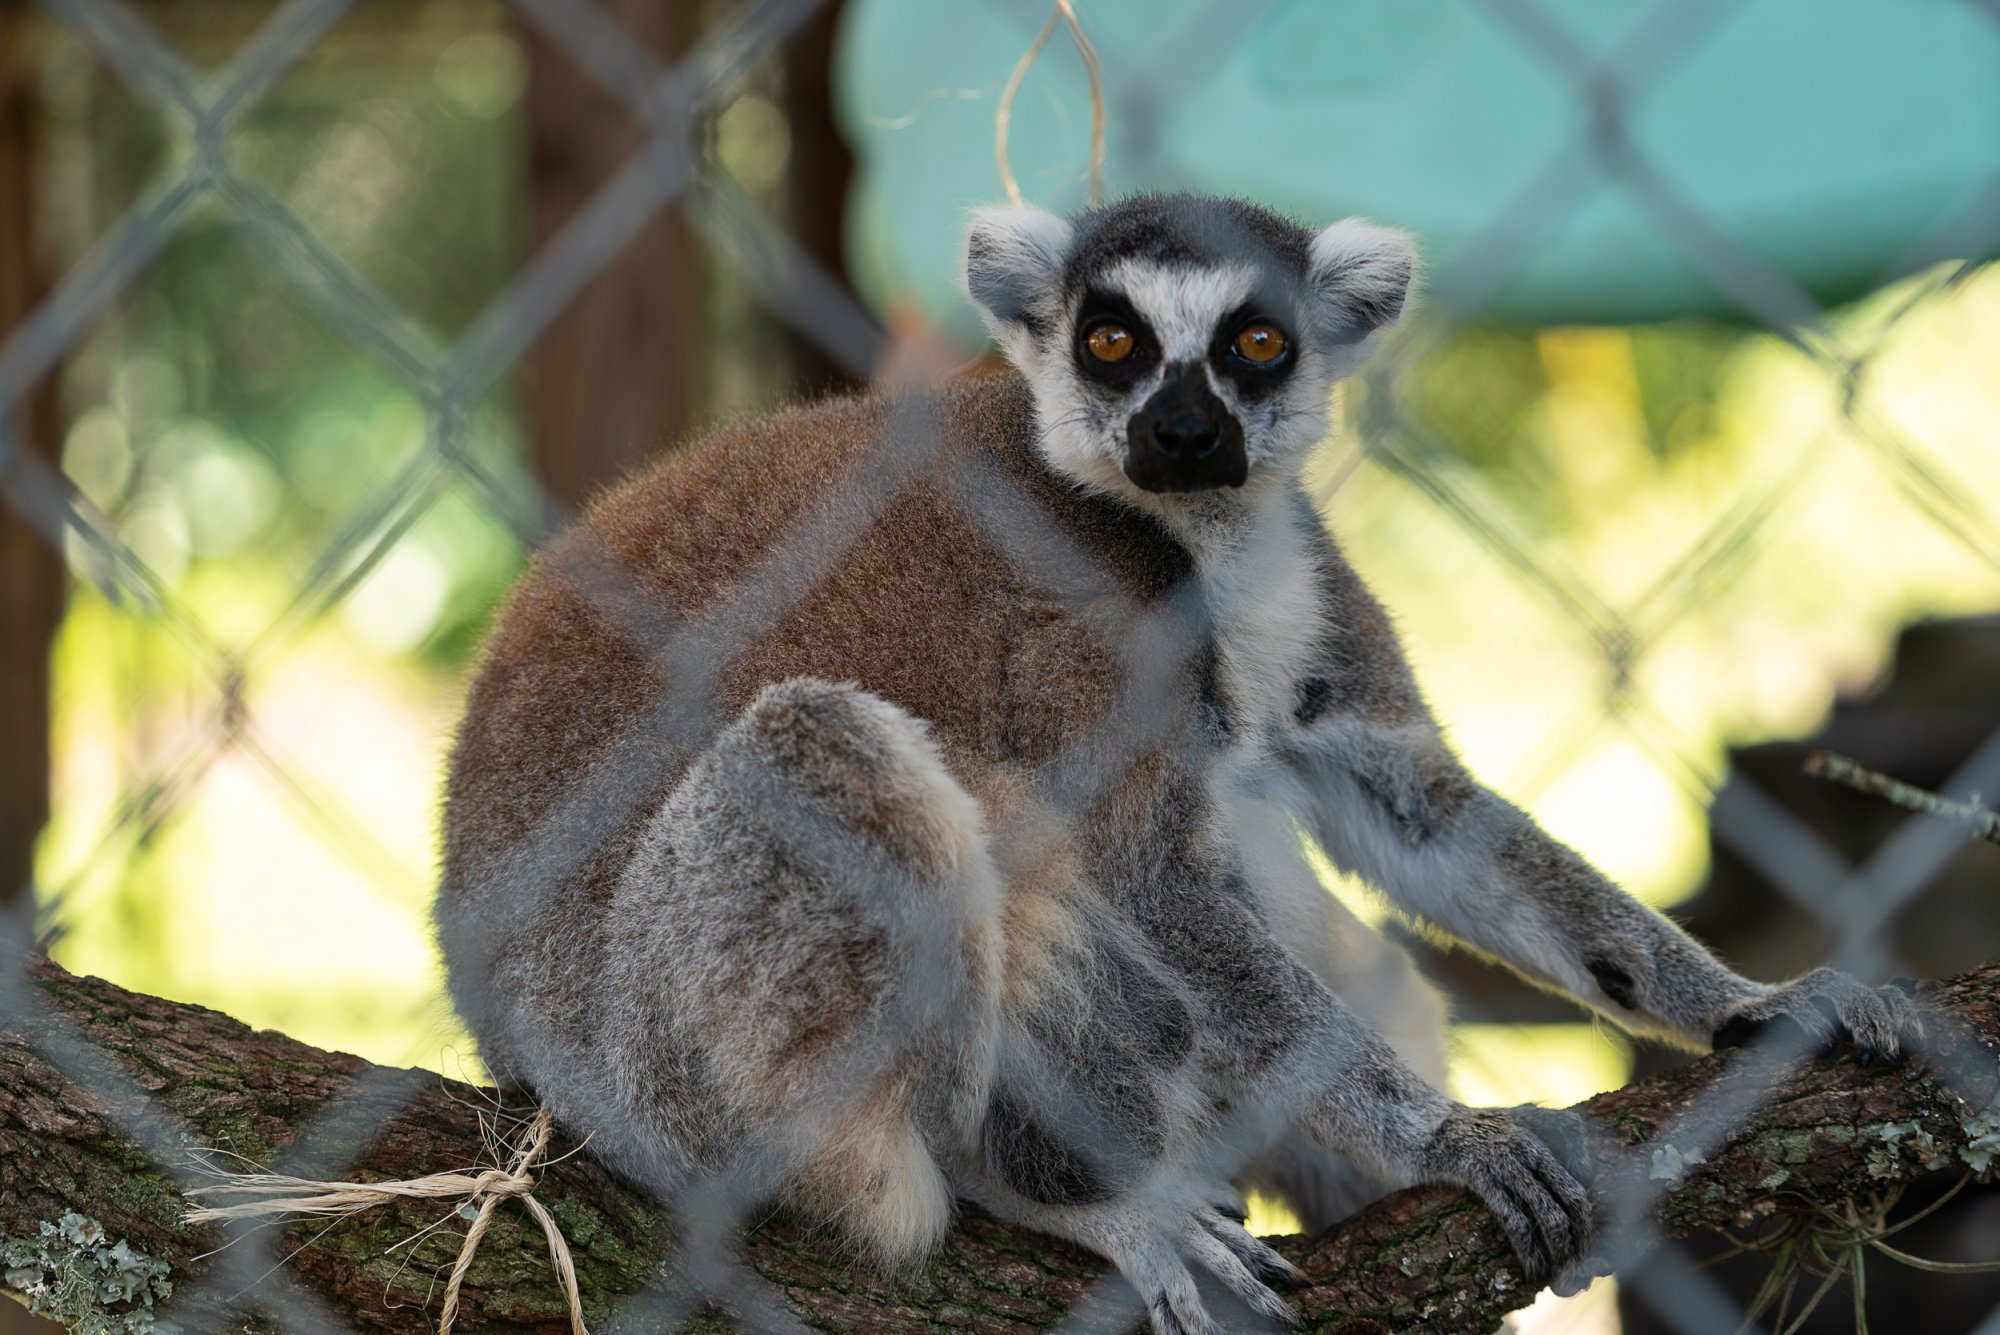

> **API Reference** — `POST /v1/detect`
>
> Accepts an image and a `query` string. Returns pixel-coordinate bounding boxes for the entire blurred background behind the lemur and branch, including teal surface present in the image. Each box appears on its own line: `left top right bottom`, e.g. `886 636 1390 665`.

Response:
0 0 2000 1331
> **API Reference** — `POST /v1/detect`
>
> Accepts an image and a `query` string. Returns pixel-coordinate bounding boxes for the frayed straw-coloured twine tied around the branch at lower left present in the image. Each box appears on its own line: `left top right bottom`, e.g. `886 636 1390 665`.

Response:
182 1105 590 1335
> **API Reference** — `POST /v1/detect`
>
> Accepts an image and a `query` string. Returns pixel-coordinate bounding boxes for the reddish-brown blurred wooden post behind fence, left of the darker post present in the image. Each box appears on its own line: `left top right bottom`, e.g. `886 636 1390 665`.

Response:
524 0 700 506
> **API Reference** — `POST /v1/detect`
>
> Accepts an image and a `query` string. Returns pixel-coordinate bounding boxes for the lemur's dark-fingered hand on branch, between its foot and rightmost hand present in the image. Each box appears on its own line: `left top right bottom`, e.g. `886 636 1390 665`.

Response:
1420 1107 1590 1289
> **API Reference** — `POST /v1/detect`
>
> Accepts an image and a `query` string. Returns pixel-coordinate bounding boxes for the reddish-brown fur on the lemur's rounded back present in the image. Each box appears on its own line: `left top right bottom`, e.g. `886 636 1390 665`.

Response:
442 365 1190 943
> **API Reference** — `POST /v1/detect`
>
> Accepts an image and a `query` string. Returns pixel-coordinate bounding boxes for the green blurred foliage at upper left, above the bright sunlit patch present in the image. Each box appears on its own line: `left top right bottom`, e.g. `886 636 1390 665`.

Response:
42 4 526 668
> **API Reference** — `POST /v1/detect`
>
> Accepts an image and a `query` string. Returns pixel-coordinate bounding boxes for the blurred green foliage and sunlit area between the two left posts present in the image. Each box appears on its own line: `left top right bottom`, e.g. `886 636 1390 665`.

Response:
40 4 532 1063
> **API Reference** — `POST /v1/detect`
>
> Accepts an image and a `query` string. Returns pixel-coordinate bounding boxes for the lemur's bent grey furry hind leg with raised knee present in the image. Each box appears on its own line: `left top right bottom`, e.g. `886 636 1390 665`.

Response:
600 677 1000 1263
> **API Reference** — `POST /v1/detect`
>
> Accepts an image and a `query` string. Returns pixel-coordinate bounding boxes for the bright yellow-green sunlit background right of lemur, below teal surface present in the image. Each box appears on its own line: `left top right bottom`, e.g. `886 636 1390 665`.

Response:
1308 263 2000 927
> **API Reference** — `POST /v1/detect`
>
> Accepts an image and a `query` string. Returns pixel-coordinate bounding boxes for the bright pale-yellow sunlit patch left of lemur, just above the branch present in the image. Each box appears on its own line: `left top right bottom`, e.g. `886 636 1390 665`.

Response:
42 582 470 1067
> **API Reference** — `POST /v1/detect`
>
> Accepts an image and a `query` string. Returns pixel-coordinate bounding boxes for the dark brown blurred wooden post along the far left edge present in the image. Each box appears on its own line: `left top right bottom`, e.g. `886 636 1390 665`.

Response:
0 0 62 907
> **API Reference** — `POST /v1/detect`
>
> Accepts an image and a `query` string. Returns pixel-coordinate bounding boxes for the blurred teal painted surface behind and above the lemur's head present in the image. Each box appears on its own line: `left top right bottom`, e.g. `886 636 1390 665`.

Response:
838 0 2000 334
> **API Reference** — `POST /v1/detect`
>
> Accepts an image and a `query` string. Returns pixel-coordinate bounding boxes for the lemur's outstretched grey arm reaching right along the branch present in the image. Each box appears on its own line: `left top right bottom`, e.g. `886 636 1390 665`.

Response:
1292 522 1920 1057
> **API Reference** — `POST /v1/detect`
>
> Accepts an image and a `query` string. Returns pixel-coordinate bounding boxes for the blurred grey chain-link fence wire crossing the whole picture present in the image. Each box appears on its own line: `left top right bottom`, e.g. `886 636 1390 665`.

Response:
0 0 2000 1331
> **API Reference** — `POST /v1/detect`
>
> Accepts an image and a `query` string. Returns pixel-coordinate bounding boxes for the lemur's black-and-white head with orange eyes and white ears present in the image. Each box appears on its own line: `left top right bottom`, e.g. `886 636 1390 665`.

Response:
966 194 1416 505
